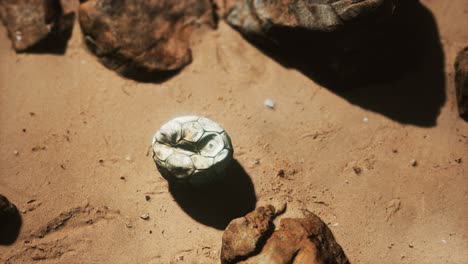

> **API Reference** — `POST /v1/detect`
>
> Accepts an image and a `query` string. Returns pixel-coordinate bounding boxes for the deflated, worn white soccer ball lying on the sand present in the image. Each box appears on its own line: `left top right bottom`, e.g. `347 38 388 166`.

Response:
152 116 233 186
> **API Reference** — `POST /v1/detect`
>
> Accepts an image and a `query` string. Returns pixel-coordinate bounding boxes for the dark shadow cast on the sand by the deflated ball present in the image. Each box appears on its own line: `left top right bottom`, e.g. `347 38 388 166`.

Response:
169 160 257 230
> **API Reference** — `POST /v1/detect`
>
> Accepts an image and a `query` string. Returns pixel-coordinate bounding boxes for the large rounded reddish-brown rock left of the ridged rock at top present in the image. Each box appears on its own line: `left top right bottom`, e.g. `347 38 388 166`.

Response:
79 0 214 79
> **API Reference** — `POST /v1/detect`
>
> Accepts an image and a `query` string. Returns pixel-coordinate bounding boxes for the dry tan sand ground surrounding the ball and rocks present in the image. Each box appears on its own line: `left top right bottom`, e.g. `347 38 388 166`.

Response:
0 0 468 264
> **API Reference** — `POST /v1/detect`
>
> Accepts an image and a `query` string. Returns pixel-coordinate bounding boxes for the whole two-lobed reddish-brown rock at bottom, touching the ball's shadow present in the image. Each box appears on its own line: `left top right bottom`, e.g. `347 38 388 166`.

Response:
221 207 349 264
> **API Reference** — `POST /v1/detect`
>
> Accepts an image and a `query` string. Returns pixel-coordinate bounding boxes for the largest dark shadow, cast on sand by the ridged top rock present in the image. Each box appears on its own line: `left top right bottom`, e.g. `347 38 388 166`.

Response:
234 1 446 127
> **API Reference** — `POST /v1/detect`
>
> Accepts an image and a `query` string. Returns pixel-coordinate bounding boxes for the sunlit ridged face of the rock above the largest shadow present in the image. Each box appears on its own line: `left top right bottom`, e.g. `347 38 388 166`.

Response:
226 0 397 35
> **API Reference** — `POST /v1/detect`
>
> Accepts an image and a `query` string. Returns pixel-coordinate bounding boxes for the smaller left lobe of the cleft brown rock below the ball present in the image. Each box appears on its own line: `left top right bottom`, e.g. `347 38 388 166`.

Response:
221 205 275 263
